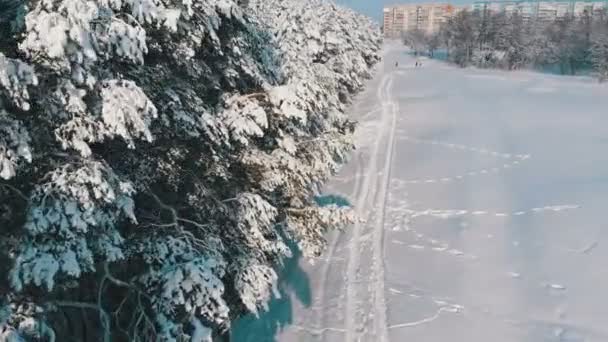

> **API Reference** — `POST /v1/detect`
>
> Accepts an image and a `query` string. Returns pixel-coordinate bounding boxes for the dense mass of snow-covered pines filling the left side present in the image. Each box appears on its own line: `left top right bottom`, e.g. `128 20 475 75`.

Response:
0 0 381 341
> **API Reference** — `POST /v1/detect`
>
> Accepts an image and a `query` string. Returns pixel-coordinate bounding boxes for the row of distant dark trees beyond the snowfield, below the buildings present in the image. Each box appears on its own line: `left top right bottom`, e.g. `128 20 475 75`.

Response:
404 11 608 81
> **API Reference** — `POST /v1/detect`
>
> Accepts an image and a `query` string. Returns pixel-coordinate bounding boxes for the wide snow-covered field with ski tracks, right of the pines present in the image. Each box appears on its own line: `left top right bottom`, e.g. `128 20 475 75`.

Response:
234 44 608 342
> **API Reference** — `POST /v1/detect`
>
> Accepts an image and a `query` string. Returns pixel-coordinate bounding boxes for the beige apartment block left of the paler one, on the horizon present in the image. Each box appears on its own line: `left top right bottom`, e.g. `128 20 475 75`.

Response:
383 3 458 38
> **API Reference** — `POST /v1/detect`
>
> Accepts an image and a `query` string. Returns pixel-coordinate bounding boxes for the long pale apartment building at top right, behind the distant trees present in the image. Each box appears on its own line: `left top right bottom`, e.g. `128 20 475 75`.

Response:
471 0 608 21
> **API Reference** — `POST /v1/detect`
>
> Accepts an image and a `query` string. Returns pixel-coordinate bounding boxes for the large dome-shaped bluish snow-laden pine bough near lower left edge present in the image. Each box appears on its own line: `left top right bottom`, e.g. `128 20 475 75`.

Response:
10 162 136 291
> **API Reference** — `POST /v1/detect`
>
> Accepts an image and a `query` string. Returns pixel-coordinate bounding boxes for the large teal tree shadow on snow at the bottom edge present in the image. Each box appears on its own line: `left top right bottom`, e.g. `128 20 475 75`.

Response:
230 243 312 342
